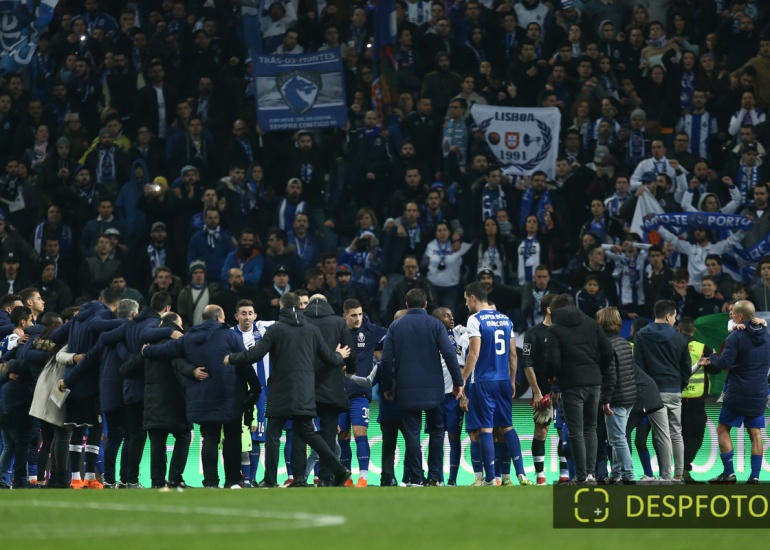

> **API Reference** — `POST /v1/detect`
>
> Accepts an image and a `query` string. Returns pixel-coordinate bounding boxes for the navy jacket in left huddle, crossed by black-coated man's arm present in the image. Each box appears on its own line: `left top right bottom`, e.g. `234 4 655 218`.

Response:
102 307 174 405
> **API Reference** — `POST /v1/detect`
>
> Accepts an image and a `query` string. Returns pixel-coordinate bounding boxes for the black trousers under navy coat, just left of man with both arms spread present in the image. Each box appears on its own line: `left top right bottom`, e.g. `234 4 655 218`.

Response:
198 418 242 487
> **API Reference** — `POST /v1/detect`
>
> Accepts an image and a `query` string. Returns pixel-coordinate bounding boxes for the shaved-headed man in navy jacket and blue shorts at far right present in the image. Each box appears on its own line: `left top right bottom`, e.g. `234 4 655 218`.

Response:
698 300 770 485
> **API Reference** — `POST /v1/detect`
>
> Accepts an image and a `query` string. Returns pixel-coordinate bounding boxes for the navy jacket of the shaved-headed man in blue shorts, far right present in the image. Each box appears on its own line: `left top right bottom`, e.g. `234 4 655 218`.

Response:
709 324 770 416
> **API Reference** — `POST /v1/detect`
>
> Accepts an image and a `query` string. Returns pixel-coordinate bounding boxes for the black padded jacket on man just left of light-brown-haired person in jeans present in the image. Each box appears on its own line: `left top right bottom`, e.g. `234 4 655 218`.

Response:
545 306 613 390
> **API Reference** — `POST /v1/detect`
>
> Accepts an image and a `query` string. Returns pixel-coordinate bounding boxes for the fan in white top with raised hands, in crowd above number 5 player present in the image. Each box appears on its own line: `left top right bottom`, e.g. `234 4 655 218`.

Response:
421 222 471 311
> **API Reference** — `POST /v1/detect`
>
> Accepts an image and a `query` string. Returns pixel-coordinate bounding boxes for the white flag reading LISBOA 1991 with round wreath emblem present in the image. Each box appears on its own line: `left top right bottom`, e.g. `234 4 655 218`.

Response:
471 103 561 178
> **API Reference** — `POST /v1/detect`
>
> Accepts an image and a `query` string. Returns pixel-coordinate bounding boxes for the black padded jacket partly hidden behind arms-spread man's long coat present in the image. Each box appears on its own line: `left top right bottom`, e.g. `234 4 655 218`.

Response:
303 300 356 412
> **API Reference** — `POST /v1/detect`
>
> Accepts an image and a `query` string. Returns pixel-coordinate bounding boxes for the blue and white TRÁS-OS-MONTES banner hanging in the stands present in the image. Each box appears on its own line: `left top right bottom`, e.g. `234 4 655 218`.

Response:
253 49 347 132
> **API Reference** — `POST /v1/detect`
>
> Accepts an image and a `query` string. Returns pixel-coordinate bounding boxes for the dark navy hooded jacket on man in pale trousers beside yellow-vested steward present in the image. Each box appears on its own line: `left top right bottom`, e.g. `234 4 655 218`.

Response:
634 323 692 393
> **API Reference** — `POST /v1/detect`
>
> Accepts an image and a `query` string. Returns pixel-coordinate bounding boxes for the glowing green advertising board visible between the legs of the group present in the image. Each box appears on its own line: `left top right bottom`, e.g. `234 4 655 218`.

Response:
135 401 770 487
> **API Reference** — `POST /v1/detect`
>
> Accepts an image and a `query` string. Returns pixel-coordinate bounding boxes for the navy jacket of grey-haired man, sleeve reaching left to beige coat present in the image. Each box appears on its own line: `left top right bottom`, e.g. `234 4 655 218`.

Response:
64 319 127 412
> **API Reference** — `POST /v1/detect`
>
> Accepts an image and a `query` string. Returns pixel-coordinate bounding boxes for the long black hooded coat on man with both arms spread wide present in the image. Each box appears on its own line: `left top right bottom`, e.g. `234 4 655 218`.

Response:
226 308 343 418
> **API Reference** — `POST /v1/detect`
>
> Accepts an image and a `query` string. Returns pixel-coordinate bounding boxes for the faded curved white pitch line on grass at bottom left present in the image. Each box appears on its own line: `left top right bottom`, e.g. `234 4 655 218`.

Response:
0 500 347 539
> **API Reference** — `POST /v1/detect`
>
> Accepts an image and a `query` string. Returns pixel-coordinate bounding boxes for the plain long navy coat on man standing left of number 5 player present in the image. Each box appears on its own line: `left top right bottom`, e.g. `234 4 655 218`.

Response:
382 308 463 410
